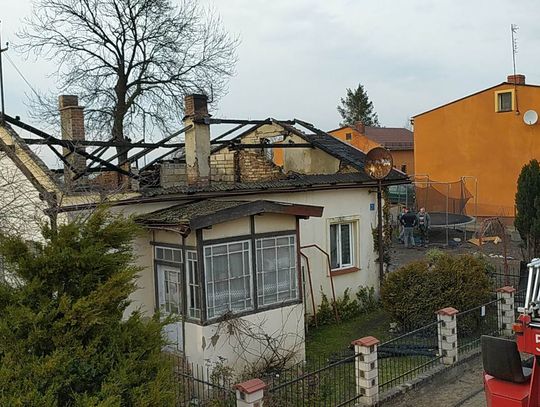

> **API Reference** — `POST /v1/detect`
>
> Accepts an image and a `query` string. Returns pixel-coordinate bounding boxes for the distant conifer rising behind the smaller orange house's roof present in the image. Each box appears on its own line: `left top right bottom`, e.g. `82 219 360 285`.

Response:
337 84 379 127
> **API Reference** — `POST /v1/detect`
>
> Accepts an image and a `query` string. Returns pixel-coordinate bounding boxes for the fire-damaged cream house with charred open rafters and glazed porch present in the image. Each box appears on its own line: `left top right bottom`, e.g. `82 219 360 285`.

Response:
0 95 409 368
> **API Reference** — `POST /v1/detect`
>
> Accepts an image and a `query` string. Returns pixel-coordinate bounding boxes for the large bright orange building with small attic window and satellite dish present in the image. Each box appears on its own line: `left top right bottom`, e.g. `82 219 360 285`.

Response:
414 75 540 217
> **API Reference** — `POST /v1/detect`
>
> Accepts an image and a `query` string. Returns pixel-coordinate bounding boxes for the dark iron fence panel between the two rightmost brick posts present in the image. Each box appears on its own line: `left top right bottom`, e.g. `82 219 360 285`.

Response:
456 299 502 355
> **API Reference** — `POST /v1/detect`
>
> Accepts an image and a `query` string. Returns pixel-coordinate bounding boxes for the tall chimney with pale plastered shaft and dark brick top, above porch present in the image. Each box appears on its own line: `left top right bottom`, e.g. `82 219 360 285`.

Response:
184 95 210 185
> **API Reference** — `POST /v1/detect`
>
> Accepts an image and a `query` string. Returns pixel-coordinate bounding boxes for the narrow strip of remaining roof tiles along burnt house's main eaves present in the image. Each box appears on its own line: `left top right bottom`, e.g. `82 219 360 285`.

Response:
141 172 396 196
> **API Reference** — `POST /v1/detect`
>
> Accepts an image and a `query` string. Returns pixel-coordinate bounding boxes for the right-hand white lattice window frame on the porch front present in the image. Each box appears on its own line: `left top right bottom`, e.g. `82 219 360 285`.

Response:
255 235 299 308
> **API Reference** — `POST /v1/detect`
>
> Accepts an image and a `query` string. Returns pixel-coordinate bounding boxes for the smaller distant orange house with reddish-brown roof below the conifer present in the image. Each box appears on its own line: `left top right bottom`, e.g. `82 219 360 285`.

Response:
328 122 414 175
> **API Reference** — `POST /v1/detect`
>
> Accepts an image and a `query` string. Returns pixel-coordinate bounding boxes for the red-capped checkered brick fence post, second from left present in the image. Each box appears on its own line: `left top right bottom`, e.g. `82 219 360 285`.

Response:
352 336 380 406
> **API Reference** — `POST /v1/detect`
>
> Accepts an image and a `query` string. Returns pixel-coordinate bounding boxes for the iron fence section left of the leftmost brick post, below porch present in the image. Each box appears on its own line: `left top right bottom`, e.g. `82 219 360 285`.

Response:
170 354 236 407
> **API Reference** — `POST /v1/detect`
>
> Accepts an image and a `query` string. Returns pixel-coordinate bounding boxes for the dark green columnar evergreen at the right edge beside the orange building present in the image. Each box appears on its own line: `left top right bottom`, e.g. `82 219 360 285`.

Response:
514 160 540 260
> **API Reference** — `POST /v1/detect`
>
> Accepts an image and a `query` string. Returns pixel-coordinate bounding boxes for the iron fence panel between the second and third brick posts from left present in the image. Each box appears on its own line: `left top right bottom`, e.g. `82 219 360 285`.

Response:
377 321 441 393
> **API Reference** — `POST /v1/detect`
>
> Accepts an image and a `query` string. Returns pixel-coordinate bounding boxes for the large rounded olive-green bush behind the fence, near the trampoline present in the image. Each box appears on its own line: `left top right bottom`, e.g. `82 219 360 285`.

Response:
381 252 492 328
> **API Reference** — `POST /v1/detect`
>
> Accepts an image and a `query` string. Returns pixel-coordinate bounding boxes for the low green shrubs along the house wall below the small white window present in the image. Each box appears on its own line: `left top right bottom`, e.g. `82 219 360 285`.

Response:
310 286 378 325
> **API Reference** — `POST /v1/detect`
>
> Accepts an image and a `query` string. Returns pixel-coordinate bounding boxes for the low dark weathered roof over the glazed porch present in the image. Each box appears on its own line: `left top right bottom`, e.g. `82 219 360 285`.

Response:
136 199 323 230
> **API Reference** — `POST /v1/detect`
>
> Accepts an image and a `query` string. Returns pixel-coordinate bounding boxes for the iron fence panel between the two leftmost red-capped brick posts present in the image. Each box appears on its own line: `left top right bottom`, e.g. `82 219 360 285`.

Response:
262 351 361 407
